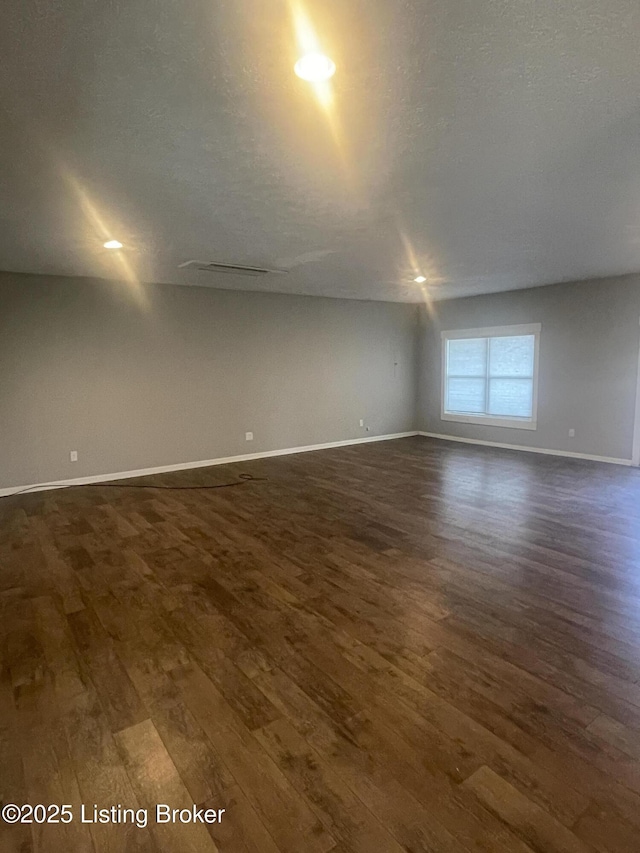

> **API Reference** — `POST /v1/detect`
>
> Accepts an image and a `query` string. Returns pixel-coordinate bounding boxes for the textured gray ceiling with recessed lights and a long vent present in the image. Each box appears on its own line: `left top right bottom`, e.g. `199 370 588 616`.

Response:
0 0 640 301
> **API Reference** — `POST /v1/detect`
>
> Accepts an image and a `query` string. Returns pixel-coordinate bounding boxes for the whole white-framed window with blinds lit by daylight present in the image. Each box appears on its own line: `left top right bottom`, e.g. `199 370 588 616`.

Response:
441 323 541 429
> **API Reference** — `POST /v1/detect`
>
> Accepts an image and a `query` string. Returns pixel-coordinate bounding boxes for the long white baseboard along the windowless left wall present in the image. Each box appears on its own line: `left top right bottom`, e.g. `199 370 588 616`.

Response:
0 432 420 498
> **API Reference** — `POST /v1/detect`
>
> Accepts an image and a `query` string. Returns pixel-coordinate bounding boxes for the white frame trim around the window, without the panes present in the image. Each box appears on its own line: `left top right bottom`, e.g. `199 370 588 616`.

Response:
440 323 542 430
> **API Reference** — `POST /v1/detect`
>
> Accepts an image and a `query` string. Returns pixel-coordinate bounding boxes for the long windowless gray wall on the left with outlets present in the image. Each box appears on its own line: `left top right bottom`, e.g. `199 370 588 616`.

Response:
0 273 417 488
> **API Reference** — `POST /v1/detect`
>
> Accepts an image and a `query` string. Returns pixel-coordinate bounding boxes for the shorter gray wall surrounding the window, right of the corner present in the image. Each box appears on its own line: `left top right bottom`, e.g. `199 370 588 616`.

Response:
418 275 640 459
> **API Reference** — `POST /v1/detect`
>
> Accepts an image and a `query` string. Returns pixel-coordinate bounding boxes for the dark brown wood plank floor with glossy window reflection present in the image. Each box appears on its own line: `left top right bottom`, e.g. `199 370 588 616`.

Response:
0 438 640 853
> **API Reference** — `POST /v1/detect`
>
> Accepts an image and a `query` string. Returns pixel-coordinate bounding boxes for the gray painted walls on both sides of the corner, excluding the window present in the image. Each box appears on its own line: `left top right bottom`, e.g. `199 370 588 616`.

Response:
6 273 640 488
